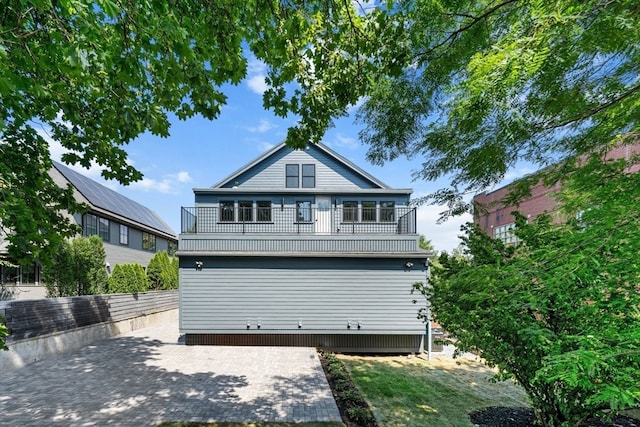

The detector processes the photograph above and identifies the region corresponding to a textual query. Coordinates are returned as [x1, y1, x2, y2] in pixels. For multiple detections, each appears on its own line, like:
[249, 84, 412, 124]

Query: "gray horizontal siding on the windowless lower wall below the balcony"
[180, 257, 426, 335]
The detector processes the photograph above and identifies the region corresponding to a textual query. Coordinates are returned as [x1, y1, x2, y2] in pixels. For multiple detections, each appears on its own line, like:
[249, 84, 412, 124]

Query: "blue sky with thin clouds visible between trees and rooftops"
[49, 55, 526, 251]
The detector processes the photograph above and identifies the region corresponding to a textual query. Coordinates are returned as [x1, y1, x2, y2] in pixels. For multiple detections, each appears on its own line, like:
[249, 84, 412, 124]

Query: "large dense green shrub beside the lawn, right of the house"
[421, 156, 640, 426]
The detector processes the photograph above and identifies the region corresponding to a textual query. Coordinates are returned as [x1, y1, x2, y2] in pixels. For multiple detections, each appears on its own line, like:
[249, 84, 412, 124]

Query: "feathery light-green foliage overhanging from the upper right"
[358, 0, 640, 214]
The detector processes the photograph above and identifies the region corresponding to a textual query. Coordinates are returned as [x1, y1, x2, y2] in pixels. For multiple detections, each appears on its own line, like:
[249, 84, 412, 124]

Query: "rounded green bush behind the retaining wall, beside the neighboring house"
[42, 236, 107, 297]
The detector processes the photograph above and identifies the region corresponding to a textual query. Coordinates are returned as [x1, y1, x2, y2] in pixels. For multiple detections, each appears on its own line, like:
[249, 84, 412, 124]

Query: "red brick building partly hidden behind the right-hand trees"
[473, 143, 640, 244]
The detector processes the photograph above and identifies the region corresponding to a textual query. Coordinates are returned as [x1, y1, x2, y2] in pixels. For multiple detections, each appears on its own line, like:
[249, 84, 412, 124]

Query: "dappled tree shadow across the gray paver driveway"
[0, 336, 340, 426]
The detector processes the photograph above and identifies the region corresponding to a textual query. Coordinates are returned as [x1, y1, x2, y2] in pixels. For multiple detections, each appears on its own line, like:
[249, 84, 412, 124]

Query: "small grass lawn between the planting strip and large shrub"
[339, 355, 529, 427]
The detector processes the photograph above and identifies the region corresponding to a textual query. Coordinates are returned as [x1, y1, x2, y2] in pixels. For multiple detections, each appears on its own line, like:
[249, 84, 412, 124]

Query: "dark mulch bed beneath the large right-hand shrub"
[469, 406, 640, 427]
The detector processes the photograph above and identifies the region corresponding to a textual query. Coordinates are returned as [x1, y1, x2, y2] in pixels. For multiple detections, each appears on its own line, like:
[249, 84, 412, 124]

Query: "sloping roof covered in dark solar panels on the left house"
[53, 161, 176, 238]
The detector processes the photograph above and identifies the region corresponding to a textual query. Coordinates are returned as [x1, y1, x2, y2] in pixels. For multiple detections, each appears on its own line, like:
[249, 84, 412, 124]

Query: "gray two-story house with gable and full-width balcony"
[178, 144, 431, 352]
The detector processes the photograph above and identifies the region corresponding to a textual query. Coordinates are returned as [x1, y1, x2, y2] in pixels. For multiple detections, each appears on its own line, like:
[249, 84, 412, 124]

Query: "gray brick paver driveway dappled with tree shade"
[0, 312, 340, 426]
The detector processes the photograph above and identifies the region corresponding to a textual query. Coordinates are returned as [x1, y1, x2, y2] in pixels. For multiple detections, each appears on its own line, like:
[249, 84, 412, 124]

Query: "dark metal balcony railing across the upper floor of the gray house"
[181, 207, 417, 234]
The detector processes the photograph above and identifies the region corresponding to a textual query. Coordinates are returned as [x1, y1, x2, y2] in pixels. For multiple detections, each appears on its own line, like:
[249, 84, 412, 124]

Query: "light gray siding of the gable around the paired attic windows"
[223, 146, 379, 189]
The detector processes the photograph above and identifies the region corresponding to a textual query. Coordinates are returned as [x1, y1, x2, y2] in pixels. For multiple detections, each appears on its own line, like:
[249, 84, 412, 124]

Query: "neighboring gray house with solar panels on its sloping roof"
[0, 162, 178, 299]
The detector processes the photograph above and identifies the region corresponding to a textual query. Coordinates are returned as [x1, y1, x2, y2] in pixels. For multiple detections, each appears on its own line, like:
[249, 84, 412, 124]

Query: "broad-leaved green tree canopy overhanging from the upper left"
[0, 0, 402, 262]
